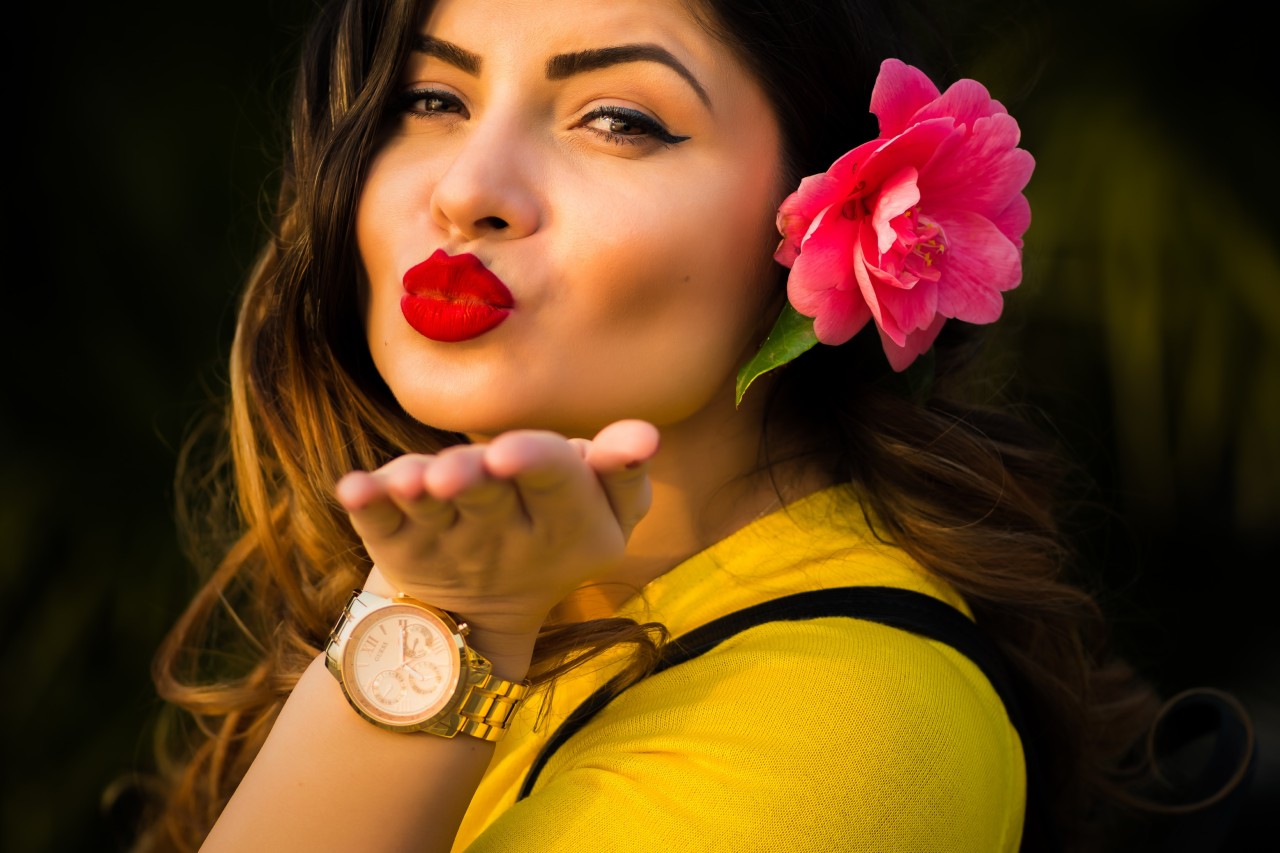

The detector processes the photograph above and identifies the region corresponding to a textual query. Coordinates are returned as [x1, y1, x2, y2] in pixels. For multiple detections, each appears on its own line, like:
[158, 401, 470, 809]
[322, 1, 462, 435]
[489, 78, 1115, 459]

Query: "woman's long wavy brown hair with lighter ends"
[137, 0, 1155, 850]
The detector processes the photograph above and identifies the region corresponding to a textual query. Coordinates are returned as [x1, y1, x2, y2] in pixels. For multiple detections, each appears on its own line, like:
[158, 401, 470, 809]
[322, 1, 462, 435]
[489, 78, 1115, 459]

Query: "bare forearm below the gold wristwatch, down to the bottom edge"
[201, 645, 524, 853]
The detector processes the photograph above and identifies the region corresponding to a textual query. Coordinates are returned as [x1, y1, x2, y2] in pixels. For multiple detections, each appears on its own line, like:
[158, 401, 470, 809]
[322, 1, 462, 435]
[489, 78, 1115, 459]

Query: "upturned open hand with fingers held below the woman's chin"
[337, 420, 658, 655]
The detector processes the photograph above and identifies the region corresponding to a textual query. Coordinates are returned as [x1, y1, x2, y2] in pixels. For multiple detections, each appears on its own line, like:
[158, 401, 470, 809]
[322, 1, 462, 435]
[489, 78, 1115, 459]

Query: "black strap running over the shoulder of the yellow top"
[517, 587, 1060, 852]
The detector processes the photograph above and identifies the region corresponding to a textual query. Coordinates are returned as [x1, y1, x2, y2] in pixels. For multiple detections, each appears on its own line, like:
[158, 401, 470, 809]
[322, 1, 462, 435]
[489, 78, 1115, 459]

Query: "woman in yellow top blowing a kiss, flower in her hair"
[148, 0, 1172, 850]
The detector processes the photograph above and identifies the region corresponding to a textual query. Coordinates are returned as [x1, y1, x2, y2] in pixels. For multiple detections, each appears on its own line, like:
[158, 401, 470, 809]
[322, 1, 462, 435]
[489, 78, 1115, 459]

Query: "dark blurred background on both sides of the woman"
[0, 0, 1280, 853]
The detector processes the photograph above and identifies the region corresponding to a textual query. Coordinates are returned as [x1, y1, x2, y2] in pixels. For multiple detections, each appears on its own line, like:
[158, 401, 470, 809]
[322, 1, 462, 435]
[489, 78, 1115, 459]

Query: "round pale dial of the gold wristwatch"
[342, 596, 461, 725]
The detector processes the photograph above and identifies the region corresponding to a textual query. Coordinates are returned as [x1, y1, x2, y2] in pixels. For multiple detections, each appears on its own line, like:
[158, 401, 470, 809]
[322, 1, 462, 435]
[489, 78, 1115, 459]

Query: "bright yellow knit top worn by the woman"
[453, 487, 1025, 853]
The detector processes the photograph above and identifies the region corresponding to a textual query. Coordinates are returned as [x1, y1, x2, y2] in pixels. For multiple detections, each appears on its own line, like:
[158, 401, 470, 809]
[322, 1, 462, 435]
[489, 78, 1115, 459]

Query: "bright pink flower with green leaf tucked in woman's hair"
[739, 59, 1036, 400]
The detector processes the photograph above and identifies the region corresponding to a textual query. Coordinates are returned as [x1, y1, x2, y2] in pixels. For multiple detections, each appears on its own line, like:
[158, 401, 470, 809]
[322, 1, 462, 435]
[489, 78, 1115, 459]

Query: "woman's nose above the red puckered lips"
[431, 109, 543, 241]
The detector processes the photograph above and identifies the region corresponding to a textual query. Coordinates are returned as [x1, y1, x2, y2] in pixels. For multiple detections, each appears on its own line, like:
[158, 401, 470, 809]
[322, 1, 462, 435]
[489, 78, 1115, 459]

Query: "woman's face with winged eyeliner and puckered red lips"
[357, 0, 783, 435]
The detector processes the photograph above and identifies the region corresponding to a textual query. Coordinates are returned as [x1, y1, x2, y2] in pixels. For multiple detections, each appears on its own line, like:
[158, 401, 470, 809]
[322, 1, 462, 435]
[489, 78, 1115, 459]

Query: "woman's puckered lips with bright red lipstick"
[401, 248, 516, 343]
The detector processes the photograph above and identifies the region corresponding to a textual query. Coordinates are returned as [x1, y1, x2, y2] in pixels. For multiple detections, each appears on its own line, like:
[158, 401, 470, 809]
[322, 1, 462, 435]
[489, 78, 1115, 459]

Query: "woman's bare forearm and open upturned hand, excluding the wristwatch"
[204, 421, 657, 853]
